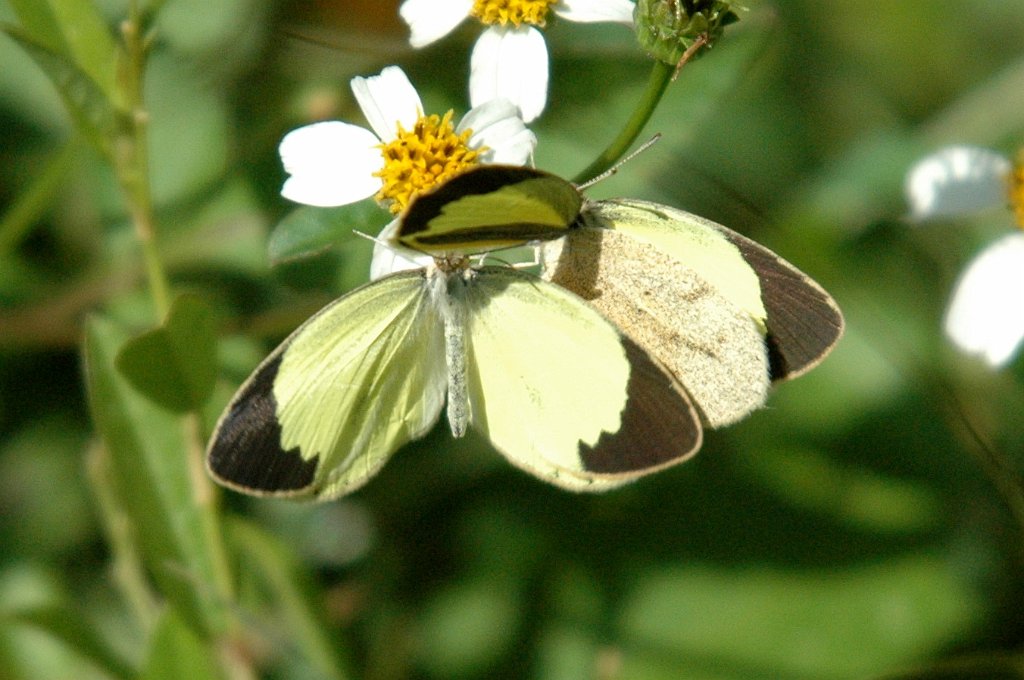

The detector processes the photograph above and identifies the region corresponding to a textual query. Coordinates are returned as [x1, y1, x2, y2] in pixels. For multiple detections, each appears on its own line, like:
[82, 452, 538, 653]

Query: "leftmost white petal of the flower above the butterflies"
[278, 121, 384, 207]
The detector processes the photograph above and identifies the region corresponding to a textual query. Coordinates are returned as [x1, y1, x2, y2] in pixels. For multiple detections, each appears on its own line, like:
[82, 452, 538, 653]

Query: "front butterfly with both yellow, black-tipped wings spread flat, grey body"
[207, 228, 701, 500]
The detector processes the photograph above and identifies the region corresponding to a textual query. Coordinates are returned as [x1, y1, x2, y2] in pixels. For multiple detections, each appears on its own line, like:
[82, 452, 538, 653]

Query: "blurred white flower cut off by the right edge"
[906, 145, 1024, 369]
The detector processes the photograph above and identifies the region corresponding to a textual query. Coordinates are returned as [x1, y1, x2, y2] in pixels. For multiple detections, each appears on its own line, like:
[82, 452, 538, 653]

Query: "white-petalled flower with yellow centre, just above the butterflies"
[279, 67, 537, 213]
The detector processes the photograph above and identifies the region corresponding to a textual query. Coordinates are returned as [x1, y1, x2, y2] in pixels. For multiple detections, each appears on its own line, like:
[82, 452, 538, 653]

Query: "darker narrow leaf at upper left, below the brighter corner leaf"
[3, 25, 117, 157]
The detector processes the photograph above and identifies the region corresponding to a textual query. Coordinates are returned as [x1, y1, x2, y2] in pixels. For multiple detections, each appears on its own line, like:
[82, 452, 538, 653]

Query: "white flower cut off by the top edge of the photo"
[398, 0, 633, 123]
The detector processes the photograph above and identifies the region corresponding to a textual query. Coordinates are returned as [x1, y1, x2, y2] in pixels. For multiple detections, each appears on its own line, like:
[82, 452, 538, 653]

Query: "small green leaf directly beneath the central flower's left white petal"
[267, 199, 390, 264]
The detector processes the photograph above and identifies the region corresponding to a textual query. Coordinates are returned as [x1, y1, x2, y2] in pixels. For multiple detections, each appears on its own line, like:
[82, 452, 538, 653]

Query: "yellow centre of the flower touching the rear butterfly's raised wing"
[374, 111, 487, 215]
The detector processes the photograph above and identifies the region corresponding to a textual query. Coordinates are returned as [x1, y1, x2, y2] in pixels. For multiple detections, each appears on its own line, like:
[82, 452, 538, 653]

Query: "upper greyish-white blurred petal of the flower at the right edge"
[906, 145, 1010, 219]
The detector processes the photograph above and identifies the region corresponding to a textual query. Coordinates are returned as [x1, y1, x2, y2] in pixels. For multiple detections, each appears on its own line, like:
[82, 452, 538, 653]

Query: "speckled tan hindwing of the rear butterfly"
[545, 226, 769, 427]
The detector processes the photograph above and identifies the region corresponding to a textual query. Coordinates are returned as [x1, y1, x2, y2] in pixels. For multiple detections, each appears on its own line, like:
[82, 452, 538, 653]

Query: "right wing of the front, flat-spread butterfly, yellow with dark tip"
[458, 267, 701, 491]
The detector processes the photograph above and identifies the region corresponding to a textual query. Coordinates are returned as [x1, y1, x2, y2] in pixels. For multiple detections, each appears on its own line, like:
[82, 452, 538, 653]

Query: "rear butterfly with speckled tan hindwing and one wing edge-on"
[394, 166, 844, 427]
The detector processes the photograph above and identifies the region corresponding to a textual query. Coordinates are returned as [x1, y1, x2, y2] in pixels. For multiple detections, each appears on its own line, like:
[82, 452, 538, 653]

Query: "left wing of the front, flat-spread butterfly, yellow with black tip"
[207, 270, 446, 499]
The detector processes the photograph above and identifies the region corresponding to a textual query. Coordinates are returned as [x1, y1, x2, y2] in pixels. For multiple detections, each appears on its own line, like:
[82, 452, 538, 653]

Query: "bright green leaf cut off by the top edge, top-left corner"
[10, 0, 118, 101]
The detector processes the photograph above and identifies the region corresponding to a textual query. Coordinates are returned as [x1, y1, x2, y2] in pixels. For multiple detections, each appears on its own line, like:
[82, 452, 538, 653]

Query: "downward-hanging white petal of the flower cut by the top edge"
[469, 26, 548, 123]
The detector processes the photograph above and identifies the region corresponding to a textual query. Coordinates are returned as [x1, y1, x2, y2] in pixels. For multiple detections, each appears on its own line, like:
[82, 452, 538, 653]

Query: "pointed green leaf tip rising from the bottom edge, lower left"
[140, 609, 224, 680]
